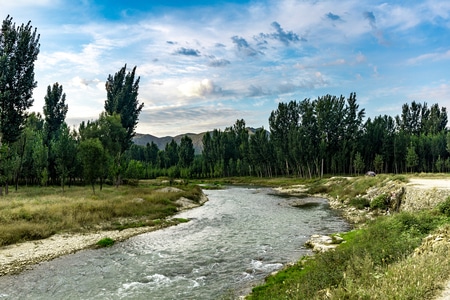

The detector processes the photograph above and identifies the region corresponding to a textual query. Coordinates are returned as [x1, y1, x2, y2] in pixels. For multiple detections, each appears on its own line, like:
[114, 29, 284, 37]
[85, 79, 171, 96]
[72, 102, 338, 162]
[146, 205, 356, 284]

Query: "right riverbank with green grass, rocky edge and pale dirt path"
[248, 175, 450, 300]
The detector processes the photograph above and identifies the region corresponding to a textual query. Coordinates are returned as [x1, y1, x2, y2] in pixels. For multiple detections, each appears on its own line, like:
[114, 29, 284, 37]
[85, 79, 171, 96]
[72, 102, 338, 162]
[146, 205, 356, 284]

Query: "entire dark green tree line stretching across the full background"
[0, 16, 450, 194]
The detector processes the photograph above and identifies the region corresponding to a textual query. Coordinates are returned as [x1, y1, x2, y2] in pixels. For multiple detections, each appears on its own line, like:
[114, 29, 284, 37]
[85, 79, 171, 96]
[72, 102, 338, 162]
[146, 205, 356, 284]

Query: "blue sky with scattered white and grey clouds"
[0, 0, 450, 137]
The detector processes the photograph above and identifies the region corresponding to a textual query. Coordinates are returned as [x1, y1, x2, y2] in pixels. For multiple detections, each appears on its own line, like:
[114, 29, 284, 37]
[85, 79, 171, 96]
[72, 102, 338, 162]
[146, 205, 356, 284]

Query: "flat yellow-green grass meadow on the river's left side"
[0, 183, 201, 246]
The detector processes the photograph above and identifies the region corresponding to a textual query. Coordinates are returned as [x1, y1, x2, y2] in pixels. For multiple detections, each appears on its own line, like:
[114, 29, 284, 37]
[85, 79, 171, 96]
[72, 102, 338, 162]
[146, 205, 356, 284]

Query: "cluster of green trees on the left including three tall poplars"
[0, 16, 147, 194]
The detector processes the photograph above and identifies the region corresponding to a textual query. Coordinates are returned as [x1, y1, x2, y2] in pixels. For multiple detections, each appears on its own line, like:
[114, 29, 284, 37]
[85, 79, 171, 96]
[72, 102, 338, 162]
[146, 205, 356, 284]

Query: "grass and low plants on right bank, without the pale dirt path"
[246, 176, 450, 299]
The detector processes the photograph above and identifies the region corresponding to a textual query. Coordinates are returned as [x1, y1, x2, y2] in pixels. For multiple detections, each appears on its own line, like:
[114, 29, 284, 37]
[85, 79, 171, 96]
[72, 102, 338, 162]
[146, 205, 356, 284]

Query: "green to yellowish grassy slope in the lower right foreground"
[247, 212, 450, 299]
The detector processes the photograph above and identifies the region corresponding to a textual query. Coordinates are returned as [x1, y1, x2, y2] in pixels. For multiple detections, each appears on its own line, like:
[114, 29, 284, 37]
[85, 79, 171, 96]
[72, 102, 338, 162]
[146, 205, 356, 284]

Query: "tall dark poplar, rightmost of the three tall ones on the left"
[105, 65, 144, 153]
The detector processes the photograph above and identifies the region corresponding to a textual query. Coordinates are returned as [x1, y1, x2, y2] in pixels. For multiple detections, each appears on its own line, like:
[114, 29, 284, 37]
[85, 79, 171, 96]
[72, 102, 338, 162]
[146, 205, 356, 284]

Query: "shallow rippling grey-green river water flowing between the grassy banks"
[0, 187, 349, 299]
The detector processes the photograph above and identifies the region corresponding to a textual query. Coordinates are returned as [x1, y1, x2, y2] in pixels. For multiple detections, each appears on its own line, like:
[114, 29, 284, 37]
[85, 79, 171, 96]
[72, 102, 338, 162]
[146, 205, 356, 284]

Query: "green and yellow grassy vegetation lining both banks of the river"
[0, 175, 450, 299]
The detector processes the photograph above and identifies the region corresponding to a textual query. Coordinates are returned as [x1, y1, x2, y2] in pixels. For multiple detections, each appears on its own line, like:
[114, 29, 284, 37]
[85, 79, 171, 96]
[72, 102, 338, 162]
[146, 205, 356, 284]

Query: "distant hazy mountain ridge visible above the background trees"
[133, 127, 262, 154]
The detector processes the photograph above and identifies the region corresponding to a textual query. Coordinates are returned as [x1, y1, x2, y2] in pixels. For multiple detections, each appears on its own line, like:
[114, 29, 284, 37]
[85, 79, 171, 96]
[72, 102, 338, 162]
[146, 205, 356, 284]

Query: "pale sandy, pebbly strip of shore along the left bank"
[0, 187, 208, 276]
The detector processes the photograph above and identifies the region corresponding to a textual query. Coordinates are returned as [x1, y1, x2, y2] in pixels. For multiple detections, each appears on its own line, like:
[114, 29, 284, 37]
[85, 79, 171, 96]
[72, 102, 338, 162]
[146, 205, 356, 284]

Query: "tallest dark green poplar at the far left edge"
[0, 16, 40, 143]
